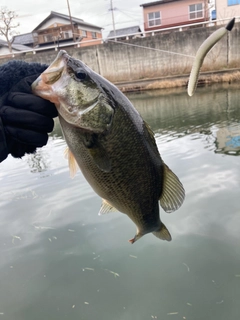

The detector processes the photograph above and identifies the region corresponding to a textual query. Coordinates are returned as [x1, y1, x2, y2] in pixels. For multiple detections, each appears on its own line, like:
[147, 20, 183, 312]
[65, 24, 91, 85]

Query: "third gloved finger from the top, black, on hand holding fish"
[4, 126, 48, 147]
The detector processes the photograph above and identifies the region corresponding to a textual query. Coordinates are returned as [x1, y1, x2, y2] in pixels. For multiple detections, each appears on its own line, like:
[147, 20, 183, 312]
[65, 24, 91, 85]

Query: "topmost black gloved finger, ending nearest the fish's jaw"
[7, 92, 58, 118]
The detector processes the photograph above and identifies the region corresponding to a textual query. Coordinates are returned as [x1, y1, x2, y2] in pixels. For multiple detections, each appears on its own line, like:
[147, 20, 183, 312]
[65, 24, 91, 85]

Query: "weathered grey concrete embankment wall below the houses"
[0, 23, 240, 82]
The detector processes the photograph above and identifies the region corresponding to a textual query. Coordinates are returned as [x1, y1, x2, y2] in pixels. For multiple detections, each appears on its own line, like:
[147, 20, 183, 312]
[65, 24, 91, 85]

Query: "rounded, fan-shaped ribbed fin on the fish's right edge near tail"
[159, 163, 185, 213]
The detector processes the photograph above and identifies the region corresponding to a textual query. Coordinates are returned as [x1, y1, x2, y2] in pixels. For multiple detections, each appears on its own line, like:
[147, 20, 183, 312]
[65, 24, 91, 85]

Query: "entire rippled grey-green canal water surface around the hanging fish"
[0, 85, 240, 320]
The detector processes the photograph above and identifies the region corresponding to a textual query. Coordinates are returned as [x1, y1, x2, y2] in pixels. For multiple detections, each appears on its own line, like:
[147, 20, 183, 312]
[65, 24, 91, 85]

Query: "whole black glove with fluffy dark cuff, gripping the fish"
[0, 61, 58, 161]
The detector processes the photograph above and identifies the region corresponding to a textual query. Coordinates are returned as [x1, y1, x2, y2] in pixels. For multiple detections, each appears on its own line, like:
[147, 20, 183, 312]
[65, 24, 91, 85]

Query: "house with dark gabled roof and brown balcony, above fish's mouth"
[32, 11, 102, 47]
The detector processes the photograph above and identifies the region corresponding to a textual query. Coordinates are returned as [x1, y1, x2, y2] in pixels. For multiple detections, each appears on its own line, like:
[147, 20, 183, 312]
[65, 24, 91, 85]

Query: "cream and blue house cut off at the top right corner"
[215, 0, 240, 23]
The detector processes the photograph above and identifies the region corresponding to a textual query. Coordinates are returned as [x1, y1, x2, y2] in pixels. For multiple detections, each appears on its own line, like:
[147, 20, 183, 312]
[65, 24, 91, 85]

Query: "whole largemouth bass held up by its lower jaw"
[32, 51, 185, 243]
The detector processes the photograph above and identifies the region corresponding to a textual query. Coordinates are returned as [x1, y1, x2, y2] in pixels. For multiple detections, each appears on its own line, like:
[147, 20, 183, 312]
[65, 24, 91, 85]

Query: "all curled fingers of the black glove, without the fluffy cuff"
[0, 92, 57, 158]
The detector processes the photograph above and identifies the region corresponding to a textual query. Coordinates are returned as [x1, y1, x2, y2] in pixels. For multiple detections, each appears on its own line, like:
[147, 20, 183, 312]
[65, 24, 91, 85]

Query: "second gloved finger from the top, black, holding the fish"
[0, 106, 54, 132]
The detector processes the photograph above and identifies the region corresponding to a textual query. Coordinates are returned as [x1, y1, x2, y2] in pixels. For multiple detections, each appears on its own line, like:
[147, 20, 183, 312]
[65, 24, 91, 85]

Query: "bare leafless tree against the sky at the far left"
[0, 7, 20, 52]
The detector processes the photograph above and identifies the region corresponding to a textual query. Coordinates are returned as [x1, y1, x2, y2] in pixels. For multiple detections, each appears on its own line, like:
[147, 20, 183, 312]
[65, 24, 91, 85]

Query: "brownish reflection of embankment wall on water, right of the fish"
[129, 85, 240, 155]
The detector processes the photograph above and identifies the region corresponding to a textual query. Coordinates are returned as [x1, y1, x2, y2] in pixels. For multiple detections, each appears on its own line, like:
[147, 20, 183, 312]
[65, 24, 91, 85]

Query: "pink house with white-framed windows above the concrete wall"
[140, 0, 209, 31]
